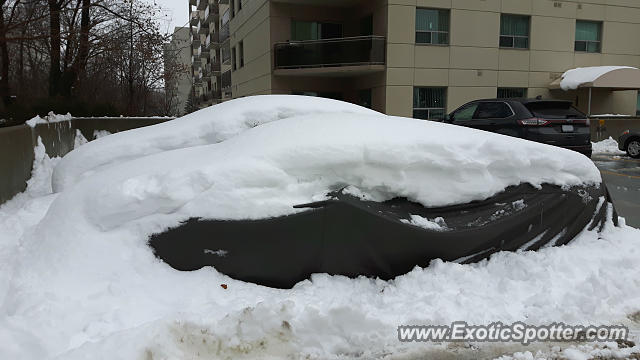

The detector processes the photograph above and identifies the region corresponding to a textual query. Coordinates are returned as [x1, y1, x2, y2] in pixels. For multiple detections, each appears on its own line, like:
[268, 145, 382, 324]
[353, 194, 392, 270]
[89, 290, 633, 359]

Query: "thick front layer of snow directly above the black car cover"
[45, 113, 601, 233]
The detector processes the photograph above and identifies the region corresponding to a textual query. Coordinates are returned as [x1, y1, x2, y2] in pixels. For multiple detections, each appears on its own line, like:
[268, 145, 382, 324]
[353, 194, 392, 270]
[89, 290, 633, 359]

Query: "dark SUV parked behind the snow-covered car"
[446, 99, 592, 157]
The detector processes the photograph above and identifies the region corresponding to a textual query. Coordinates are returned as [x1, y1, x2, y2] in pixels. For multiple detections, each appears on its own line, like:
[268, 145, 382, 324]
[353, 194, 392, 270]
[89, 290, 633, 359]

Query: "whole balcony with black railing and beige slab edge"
[274, 36, 386, 76]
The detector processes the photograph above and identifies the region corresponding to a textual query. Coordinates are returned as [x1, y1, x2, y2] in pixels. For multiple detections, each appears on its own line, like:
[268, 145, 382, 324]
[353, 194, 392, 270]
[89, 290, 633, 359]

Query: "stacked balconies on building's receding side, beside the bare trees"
[189, 0, 231, 108]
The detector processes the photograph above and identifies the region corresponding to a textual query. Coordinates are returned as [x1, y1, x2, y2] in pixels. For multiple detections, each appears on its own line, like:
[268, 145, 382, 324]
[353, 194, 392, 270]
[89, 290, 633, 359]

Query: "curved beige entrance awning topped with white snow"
[549, 66, 640, 91]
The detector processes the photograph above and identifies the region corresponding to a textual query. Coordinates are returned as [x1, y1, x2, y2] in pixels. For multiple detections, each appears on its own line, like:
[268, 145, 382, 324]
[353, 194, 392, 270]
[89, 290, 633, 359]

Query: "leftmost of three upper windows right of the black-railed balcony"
[416, 9, 449, 45]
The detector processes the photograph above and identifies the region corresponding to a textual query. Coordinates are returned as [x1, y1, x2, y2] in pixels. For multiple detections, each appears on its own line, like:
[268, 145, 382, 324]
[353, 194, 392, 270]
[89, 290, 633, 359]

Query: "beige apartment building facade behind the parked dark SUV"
[209, 0, 640, 119]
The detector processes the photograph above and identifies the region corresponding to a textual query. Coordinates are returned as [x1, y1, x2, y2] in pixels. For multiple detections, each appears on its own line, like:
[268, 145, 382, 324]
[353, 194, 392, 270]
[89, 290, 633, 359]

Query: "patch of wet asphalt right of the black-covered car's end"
[593, 154, 640, 228]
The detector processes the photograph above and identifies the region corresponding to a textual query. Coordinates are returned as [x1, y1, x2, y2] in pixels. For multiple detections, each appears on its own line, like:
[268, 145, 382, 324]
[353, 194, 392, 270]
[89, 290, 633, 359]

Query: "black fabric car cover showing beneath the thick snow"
[149, 184, 617, 288]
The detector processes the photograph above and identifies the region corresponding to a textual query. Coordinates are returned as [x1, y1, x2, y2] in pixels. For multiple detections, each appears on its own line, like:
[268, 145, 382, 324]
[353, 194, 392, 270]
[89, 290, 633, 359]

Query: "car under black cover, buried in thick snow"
[50, 96, 617, 287]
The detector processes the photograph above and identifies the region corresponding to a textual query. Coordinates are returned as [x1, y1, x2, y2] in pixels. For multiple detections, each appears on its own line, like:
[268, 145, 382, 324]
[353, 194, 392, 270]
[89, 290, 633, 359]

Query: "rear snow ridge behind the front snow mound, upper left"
[53, 95, 379, 192]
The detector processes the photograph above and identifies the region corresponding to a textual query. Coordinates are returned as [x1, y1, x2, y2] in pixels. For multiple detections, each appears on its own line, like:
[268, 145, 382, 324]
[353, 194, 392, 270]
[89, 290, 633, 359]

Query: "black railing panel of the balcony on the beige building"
[275, 36, 385, 69]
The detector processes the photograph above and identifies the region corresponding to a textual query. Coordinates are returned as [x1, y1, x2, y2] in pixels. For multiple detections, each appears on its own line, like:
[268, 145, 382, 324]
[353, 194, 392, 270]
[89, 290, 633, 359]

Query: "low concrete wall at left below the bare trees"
[0, 118, 170, 204]
